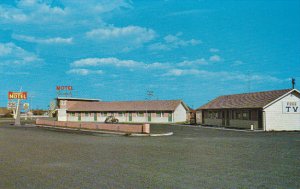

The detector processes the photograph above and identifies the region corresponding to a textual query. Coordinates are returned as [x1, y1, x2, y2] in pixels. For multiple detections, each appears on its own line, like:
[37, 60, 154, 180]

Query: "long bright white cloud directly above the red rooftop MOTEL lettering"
[71, 57, 144, 67]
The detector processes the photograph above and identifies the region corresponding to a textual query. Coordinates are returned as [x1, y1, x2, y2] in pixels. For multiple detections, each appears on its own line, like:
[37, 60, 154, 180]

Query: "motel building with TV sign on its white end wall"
[196, 89, 300, 131]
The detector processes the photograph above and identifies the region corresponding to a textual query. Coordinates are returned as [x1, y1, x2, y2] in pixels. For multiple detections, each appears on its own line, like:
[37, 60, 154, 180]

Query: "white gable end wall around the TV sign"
[264, 92, 300, 131]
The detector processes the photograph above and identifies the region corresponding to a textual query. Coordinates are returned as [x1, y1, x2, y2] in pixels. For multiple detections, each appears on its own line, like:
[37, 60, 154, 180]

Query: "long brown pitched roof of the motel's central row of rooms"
[68, 100, 187, 111]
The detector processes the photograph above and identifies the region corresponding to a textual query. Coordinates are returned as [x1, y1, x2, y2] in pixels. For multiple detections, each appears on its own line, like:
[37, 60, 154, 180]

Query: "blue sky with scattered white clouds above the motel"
[0, 0, 300, 108]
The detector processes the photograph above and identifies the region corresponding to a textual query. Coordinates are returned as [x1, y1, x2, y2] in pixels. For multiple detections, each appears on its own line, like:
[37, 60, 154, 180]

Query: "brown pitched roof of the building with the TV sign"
[197, 89, 291, 110]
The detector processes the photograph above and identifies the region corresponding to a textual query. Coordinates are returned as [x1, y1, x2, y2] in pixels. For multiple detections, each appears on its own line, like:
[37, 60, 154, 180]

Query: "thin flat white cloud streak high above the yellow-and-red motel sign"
[12, 34, 73, 44]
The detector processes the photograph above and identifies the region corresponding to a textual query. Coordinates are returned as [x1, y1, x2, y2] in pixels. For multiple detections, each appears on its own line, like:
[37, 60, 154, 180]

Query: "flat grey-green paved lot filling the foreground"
[0, 123, 300, 189]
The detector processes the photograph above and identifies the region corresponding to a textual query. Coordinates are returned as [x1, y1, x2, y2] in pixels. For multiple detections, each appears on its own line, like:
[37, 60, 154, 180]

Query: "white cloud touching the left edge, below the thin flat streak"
[0, 43, 43, 66]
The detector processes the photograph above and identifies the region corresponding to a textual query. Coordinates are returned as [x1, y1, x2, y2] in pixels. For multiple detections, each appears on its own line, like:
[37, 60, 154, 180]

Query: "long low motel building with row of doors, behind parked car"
[56, 97, 188, 123]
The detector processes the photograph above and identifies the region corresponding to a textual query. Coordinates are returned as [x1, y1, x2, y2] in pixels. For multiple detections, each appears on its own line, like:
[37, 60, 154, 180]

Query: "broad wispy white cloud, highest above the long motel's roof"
[86, 26, 156, 44]
